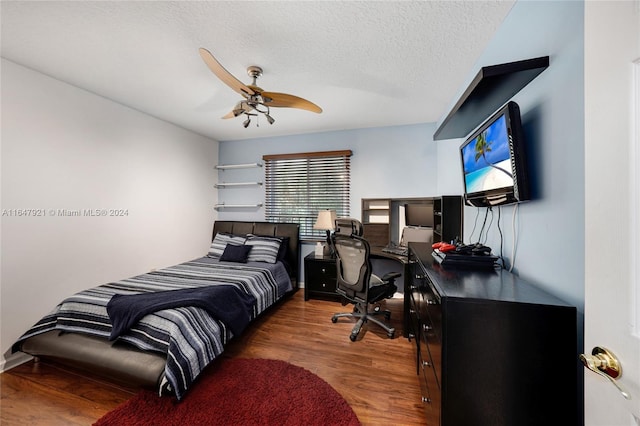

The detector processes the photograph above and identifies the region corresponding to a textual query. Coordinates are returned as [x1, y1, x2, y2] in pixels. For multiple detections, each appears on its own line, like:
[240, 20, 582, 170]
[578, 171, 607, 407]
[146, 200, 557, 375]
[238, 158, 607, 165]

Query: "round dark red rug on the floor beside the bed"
[94, 359, 360, 426]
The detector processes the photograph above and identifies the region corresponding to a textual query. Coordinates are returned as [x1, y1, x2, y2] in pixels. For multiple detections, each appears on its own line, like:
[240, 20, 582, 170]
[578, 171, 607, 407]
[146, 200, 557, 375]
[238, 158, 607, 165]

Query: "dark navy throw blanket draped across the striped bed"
[107, 285, 256, 340]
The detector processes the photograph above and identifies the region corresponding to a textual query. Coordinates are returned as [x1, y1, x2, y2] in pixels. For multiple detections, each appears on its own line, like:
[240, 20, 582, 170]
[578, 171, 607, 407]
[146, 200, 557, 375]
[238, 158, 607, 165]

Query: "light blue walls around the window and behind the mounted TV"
[218, 1, 584, 312]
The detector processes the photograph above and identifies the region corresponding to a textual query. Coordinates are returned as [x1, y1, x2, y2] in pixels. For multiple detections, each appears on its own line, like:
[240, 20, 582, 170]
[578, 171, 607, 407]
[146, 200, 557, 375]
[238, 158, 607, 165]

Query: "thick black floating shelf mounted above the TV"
[433, 56, 549, 140]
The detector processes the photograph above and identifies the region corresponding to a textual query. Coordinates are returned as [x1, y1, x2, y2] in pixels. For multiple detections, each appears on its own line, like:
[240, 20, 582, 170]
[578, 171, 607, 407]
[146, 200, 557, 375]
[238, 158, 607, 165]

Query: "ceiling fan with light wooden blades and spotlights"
[199, 47, 322, 128]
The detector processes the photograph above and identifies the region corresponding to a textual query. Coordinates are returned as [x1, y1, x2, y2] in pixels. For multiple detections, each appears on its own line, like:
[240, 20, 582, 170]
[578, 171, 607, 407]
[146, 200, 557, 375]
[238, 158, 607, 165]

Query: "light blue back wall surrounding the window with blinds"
[218, 122, 442, 220]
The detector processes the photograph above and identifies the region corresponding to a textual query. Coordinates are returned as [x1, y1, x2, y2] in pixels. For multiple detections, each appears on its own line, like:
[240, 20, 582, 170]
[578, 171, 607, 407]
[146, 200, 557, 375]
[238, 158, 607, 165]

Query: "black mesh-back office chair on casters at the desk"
[331, 219, 401, 342]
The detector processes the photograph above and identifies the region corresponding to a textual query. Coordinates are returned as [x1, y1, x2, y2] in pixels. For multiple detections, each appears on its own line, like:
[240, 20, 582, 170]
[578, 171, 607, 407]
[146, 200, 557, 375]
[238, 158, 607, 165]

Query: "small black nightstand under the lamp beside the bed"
[304, 253, 340, 300]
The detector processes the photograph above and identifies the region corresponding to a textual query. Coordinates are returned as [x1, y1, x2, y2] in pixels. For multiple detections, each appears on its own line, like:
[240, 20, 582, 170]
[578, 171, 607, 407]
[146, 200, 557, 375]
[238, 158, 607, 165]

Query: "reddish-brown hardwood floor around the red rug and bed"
[0, 290, 426, 426]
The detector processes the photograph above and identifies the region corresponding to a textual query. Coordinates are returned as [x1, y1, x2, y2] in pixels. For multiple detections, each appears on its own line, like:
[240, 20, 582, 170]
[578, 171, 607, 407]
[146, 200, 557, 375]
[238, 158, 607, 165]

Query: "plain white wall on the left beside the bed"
[0, 59, 218, 365]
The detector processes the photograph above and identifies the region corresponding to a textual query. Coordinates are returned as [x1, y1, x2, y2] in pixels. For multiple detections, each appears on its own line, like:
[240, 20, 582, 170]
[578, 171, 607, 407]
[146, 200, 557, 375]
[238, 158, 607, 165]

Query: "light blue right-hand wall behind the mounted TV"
[450, 1, 585, 312]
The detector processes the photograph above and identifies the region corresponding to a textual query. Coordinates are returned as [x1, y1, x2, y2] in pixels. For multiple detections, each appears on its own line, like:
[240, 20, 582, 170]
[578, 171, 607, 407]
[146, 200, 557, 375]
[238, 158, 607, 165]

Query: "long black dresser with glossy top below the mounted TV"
[409, 243, 582, 426]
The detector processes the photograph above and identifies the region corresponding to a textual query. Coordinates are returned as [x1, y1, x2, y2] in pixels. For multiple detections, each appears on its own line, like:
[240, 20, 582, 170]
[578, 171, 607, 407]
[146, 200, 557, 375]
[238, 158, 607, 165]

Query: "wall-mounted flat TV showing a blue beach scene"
[460, 102, 529, 207]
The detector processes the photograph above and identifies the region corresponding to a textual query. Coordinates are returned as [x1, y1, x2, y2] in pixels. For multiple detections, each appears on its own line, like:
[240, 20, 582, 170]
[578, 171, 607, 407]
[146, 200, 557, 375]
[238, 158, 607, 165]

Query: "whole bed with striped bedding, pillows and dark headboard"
[12, 221, 300, 399]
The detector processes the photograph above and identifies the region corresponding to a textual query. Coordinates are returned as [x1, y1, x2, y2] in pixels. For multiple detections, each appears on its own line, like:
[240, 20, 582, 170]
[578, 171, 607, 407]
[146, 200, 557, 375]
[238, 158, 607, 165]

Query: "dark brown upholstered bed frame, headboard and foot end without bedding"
[20, 221, 300, 389]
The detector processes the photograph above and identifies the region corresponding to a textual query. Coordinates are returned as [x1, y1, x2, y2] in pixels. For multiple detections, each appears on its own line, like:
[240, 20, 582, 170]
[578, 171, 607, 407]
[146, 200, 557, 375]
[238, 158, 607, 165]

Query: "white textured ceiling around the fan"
[0, 0, 517, 141]
